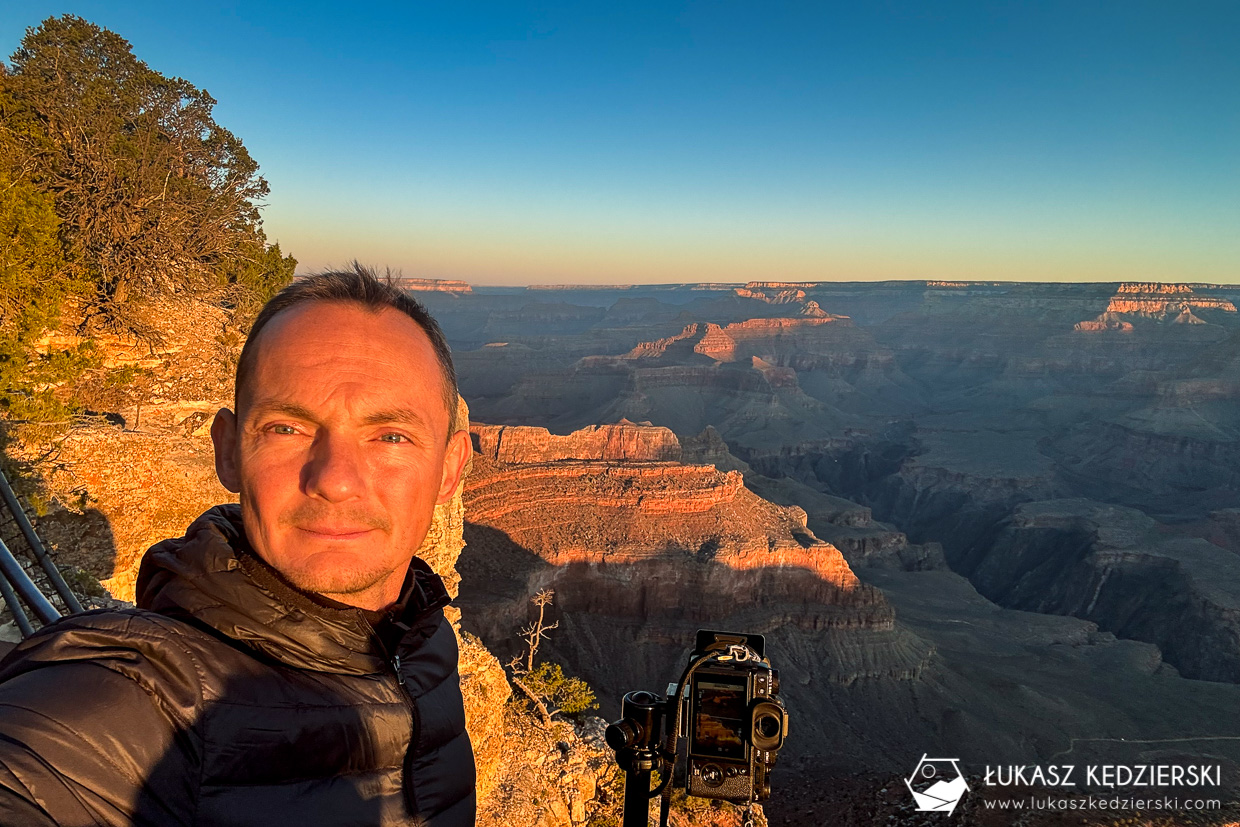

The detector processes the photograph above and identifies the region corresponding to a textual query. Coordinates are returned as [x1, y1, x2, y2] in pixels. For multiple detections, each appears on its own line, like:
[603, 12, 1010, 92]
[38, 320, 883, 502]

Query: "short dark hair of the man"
[233, 262, 461, 436]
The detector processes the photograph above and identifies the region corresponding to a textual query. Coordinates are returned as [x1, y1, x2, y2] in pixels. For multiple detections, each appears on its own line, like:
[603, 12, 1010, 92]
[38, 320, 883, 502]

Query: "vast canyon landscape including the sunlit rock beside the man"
[7, 279, 1240, 827]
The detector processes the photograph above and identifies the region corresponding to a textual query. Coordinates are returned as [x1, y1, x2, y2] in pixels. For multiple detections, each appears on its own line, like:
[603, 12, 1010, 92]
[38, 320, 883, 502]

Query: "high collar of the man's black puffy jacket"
[136, 503, 449, 674]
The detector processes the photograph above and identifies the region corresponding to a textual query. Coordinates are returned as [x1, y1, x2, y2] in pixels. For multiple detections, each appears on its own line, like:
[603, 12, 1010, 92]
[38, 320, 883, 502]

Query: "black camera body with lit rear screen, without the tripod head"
[683, 631, 787, 801]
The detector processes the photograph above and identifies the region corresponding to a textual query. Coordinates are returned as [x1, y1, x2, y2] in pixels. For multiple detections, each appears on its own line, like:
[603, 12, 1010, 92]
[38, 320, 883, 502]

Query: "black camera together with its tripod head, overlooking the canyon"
[606, 630, 787, 827]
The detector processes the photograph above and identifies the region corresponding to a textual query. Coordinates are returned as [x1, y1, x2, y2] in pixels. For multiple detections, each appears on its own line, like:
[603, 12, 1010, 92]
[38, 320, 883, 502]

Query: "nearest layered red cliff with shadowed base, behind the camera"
[460, 426, 932, 768]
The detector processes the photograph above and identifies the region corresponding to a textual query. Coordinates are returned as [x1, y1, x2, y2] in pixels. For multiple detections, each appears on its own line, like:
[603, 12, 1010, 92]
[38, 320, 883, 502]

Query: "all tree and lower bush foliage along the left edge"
[0, 15, 296, 458]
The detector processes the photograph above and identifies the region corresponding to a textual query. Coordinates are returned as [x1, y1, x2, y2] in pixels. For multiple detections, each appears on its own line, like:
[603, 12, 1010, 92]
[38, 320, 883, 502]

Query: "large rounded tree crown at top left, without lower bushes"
[0, 15, 293, 330]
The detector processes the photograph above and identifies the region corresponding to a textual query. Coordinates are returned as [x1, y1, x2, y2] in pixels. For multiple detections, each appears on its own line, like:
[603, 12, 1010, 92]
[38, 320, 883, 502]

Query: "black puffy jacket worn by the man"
[0, 506, 475, 827]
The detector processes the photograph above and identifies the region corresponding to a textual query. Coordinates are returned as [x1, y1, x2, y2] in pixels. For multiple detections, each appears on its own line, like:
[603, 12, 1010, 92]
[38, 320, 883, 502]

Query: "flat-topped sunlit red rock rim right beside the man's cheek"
[470, 420, 681, 462]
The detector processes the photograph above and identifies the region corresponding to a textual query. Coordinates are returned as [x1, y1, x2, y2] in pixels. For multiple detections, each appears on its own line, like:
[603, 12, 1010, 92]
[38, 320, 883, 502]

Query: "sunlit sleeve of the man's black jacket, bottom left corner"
[0, 662, 198, 827]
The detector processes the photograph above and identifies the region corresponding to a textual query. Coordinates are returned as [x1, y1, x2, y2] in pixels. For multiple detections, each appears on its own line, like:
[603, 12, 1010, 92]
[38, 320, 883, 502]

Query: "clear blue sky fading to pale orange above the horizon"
[0, 0, 1240, 284]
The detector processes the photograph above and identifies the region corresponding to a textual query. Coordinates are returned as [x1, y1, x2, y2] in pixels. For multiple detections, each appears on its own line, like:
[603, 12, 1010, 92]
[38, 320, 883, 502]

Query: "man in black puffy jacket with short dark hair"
[0, 265, 475, 827]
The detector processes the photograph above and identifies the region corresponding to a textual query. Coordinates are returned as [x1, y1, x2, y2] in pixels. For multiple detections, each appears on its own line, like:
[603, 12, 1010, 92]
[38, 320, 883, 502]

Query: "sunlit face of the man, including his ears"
[211, 301, 470, 609]
